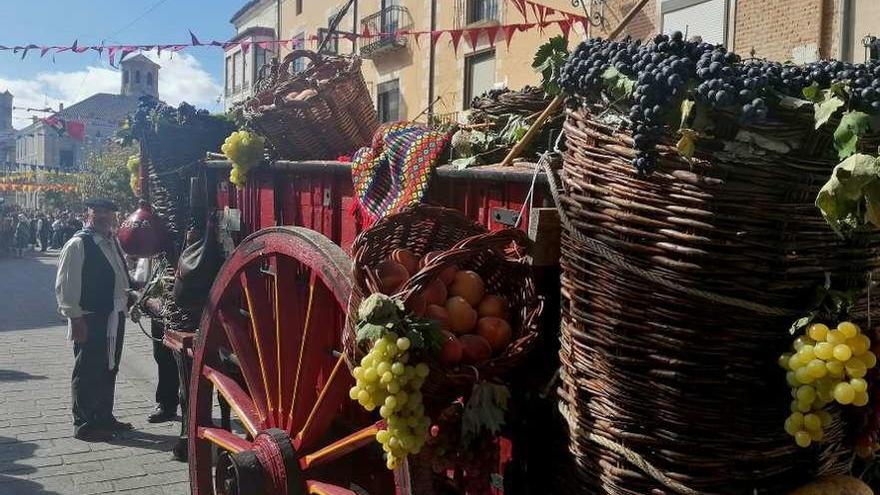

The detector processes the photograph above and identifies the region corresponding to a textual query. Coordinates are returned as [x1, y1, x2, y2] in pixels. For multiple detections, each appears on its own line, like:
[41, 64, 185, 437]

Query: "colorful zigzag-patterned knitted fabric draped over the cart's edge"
[351, 122, 452, 226]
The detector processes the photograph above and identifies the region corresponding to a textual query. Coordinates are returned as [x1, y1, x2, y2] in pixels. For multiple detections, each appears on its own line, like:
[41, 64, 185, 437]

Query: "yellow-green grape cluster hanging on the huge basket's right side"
[779, 321, 877, 447]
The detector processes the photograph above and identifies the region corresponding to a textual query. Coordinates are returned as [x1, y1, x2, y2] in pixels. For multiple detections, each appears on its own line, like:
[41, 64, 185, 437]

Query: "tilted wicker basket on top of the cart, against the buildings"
[243, 50, 379, 160]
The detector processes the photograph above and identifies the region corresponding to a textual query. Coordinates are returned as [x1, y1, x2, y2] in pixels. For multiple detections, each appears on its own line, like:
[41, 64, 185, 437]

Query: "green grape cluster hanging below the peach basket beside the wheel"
[349, 332, 431, 469]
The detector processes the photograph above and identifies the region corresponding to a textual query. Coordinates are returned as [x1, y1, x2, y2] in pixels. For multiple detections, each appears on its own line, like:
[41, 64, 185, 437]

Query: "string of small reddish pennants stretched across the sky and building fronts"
[0, 0, 589, 67]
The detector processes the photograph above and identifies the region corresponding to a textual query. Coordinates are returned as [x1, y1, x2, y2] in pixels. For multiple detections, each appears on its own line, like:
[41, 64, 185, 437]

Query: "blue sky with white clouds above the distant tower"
[0, 0, 246, 128]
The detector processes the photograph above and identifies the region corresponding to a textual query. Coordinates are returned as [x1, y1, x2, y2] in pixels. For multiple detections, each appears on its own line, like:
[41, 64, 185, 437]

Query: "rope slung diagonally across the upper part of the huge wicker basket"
[540, 153, 798, 316]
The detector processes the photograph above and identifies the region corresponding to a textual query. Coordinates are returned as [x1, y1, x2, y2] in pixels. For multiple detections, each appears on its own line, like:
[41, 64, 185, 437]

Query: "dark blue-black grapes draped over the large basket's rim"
[559, 32, 880, 174]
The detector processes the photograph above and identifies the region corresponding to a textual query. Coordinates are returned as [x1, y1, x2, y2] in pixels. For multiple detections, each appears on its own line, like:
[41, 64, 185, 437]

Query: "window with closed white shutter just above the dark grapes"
[660, 0, 727, 45]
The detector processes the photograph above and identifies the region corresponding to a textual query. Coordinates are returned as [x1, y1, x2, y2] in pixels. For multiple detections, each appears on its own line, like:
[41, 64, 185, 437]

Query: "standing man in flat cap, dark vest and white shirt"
[55, 198, 131, 441]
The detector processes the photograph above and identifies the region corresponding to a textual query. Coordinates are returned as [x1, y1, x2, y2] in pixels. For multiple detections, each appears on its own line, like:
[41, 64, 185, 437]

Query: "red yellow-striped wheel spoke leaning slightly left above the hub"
[241, 269, 279, 426]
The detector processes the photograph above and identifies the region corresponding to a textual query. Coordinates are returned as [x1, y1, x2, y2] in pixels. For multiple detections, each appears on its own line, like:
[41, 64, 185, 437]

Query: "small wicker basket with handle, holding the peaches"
[343, 205, 542, 400]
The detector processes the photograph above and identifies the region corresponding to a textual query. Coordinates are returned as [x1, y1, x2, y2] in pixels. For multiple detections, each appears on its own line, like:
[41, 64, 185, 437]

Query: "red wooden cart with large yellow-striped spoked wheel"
[166, 161, 558, 495]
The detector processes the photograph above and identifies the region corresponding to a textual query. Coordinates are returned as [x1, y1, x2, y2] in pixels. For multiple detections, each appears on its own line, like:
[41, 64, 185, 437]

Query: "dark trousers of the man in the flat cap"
[70, 313, 125, 432]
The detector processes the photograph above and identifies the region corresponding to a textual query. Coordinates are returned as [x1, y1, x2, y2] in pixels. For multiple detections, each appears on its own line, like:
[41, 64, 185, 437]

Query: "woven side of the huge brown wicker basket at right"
[558, 106, 880, 495]
